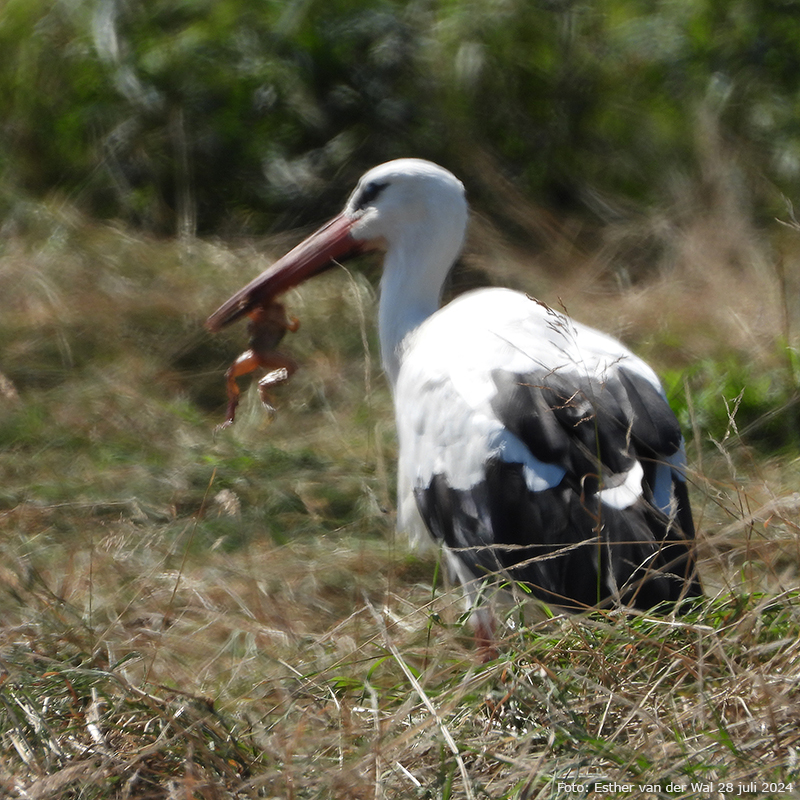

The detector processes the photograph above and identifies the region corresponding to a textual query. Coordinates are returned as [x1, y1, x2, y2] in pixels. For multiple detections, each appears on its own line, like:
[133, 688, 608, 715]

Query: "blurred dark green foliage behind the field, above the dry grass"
[0, 0, 800, 233]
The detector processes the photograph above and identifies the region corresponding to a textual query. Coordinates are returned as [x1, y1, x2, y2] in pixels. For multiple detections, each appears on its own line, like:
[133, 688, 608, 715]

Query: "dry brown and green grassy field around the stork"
[0, 195, 800, 800]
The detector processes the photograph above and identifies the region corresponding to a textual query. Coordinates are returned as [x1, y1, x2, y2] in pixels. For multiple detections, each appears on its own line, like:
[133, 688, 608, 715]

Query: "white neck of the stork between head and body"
[378, 250, 450, 389]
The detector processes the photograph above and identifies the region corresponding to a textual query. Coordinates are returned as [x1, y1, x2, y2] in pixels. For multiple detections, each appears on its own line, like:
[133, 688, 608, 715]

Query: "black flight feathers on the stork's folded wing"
[415, 367, 701, 608]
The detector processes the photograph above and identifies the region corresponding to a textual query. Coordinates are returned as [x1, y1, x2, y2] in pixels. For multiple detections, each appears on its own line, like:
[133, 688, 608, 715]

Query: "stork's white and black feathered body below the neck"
[395, 289, 695, 607]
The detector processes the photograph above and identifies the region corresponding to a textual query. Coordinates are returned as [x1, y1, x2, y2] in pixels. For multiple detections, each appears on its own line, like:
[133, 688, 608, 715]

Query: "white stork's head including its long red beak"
[206, 158, 468, 331]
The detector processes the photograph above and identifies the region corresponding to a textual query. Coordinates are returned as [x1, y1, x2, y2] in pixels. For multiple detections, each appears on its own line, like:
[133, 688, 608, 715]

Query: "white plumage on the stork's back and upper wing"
[395, 289, 680, 513]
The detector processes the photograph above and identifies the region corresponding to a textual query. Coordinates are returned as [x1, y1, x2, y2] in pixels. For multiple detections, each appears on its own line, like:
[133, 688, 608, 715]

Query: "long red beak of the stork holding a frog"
[206, 214, 368, 333]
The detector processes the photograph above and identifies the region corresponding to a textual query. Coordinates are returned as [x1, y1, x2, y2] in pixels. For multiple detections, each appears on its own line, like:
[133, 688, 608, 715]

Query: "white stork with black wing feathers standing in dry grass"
[207, 159, 701, 638]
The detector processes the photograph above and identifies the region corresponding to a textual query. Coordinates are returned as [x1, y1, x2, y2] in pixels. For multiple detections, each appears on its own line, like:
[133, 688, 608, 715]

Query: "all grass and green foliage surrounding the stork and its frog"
[0, 0, 800, 800]
